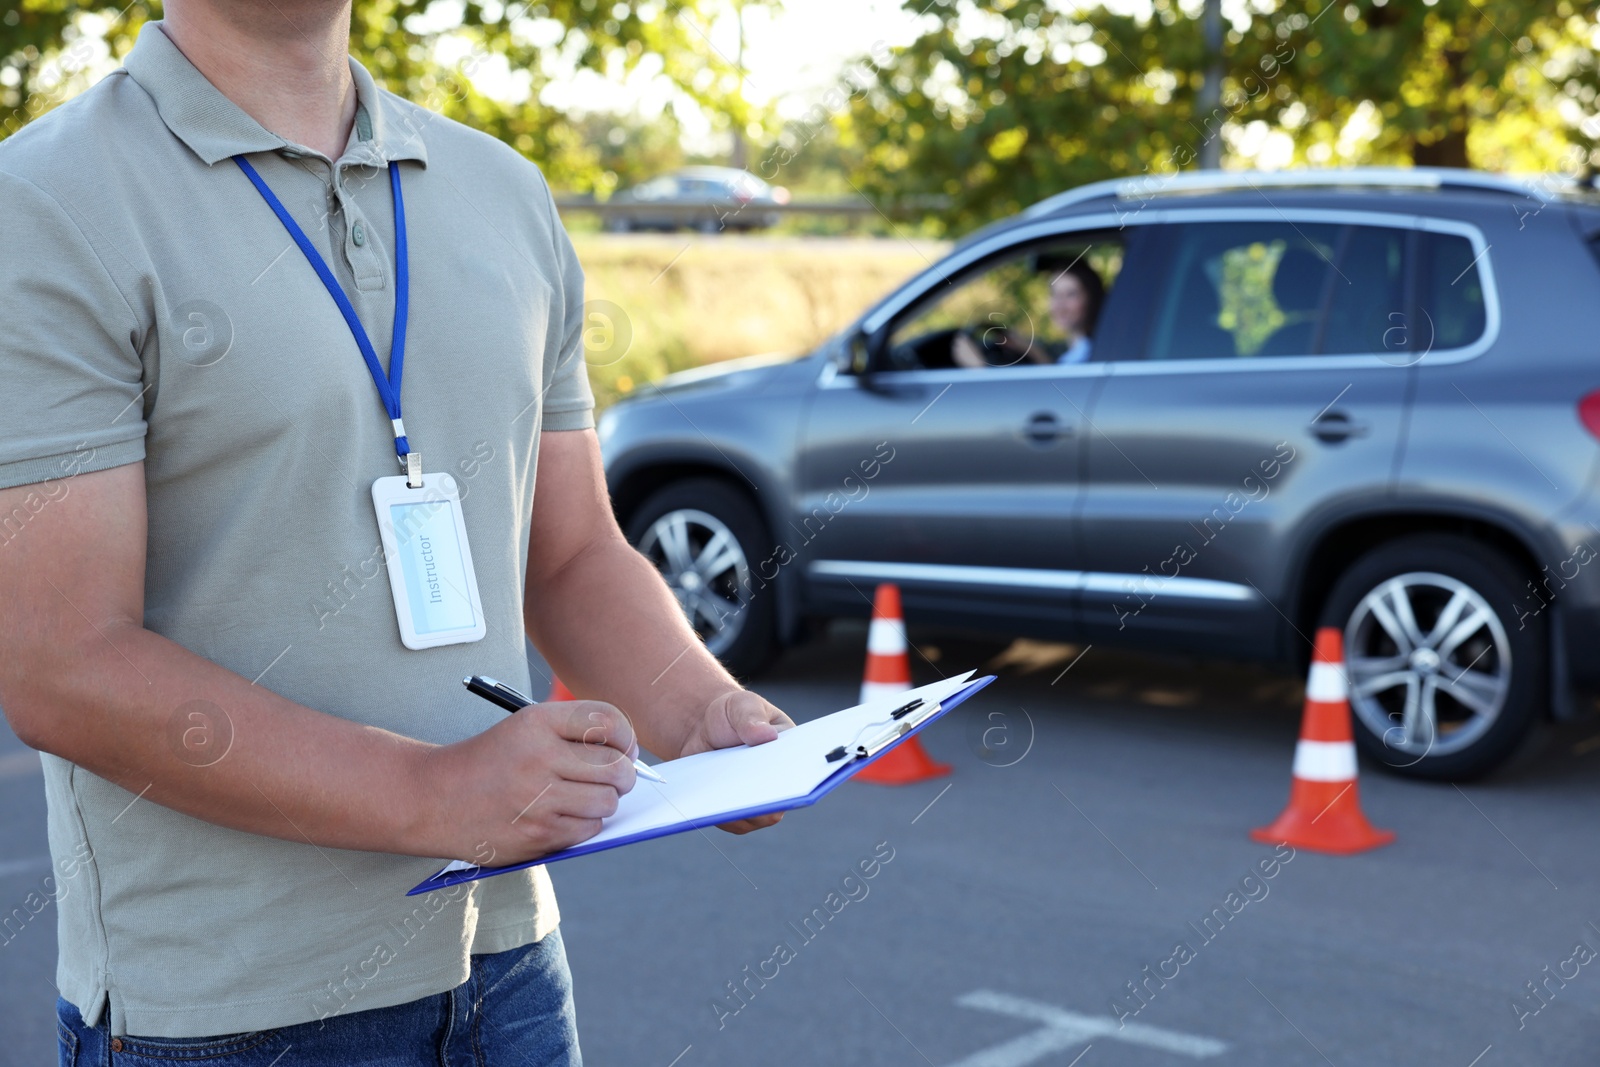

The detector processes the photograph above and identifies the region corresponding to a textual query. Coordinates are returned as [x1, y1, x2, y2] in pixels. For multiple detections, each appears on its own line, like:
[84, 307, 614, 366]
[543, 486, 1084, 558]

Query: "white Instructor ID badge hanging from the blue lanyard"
[373, 472, 488, 648]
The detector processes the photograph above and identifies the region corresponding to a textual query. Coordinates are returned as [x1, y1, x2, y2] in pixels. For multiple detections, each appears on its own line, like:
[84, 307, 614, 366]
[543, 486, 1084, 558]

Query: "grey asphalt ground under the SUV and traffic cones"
[0, 629, 1600, 1067]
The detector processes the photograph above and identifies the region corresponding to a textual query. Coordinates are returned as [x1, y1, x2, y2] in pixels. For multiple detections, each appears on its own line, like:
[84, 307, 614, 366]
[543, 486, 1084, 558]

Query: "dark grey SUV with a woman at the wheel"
[602, 170, 1600, 779]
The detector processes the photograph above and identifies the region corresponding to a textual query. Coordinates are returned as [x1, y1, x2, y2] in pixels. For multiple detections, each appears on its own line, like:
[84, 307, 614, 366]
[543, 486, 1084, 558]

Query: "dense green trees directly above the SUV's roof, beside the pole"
[843, 0, 1600, 230]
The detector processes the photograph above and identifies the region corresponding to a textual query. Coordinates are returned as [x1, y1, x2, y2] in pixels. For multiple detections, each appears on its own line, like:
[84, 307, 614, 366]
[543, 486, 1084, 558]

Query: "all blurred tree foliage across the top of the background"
[12, 0, 1600, 230]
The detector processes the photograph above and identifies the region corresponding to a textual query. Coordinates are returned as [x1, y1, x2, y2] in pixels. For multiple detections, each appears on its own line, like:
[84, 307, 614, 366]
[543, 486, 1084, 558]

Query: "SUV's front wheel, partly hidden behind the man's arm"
[627, 478, 778, 677]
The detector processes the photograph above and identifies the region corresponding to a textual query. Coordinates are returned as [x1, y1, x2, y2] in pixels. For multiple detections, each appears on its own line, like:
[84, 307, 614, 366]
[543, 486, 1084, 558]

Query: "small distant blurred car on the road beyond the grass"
[606, 166, 789, 234]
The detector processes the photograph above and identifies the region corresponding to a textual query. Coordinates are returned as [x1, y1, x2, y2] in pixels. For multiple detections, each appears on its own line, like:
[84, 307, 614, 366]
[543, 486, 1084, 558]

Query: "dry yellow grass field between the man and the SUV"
[573, 234, 947, 408]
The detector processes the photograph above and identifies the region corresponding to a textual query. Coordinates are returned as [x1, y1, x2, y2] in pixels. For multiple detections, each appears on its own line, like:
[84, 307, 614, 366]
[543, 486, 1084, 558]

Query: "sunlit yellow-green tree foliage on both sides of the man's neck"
[0, 0, 774, 192]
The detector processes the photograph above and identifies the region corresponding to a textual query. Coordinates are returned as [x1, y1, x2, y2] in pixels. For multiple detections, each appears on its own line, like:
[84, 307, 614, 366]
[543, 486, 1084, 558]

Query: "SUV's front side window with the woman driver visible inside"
[883, 235, 1123, 370]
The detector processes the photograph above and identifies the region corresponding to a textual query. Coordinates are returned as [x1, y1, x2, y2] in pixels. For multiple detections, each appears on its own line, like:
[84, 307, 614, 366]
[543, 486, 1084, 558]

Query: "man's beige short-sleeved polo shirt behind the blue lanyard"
[0, 24, 592, 1037]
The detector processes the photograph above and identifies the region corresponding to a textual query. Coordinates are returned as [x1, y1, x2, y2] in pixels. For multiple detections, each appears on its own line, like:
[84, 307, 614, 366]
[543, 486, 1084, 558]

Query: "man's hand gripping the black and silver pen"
[419, 701, 638, 867]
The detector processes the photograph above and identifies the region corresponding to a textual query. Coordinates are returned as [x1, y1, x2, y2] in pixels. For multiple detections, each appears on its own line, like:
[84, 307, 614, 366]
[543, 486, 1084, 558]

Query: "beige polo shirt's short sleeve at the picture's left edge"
[0, 173, 146, 488]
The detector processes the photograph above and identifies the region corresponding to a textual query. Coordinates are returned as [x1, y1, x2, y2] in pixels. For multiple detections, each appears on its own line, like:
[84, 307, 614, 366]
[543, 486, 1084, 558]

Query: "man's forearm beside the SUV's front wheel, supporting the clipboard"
[523, 536, 739, 760]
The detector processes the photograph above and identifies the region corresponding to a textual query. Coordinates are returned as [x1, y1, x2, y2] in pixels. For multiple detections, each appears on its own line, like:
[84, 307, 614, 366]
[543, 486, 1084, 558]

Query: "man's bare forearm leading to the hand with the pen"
[0, 624, 440, 854]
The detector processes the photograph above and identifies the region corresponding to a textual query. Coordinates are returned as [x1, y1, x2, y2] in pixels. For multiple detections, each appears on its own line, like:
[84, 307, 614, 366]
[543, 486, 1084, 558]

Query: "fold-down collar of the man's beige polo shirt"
[123, 22, 427, 166]
